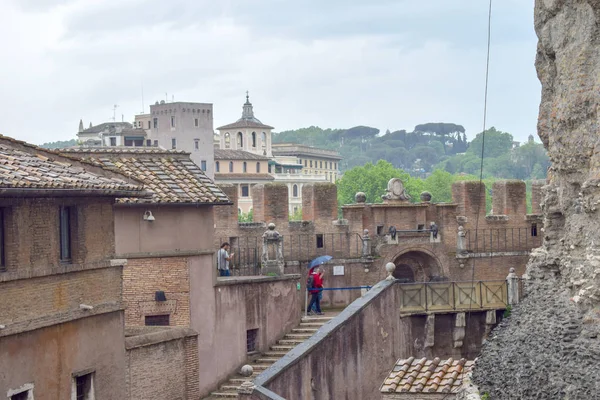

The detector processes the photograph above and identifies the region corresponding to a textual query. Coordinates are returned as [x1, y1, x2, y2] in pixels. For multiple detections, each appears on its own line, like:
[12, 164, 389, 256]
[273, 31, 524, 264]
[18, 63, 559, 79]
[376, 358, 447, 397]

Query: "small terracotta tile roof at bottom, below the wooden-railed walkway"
[380, 357, 473, 393]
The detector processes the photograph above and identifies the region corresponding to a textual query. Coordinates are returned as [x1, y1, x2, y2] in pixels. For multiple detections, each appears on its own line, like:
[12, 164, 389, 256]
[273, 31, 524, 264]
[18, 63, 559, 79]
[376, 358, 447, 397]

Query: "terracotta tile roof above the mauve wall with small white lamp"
[62, 147, 229, 204]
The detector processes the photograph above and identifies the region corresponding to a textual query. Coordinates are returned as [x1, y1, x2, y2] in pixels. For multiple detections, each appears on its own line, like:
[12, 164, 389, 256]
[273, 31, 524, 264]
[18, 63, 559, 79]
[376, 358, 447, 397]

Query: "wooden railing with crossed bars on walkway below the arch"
[399, 280, 508, 314]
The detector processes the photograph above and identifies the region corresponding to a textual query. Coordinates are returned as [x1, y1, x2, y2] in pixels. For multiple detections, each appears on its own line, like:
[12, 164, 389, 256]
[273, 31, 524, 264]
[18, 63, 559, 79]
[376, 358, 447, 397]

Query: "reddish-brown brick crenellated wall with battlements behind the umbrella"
[215, 180, 544, 285]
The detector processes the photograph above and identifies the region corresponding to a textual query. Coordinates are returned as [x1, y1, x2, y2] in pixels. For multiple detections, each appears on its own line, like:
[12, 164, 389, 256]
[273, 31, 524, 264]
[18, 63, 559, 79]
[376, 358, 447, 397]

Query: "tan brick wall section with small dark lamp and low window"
[123, 257, 190, 326]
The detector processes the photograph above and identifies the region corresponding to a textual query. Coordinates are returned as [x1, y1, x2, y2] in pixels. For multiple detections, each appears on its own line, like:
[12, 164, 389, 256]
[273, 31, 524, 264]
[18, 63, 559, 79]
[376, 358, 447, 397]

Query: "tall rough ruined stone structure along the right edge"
[473, 0, 600, 399]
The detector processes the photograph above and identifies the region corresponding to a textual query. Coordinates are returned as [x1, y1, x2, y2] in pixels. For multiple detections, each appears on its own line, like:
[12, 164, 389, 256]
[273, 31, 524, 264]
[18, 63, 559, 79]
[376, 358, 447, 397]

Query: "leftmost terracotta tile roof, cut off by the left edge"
[0, 135, 147, 197]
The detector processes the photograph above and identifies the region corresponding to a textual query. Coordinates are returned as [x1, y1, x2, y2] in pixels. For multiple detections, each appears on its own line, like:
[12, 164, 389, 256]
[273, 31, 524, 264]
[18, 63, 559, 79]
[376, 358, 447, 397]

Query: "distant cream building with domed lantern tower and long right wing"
[214, 94, 341, 213]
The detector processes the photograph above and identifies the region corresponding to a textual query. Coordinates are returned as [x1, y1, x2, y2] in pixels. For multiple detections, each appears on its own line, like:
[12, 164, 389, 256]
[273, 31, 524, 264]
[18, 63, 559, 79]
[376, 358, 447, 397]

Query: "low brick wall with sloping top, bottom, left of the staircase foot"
[125, 327, 199, 400]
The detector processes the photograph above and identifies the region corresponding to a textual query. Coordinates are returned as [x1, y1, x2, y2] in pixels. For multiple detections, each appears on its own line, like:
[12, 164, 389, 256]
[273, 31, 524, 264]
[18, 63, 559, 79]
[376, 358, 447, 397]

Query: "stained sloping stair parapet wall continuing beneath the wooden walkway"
[243, 280, 500, 400]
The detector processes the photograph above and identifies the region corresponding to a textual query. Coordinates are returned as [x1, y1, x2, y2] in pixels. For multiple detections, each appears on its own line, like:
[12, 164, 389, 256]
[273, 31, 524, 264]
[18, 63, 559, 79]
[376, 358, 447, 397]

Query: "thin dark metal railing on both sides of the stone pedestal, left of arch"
[219, 232, 363, 276]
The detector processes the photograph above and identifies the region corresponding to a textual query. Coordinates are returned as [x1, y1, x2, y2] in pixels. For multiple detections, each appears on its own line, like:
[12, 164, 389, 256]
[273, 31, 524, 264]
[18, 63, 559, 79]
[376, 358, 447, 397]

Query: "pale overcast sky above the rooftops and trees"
[0, 0, 540, 143]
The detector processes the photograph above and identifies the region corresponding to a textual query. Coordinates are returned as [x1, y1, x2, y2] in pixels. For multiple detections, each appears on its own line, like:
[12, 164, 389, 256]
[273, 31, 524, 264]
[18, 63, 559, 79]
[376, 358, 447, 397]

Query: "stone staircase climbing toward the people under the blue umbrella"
[204, 311, 338, 400]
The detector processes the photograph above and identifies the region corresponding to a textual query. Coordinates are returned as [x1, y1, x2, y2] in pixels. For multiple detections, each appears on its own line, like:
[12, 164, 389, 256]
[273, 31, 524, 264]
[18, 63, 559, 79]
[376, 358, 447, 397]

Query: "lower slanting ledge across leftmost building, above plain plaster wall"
[0, 301, 124, 338]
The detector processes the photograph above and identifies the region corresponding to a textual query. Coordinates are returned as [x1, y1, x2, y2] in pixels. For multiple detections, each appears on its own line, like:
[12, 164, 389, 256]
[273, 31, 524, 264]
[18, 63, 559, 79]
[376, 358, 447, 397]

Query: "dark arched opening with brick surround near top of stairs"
[393, 249, 444, 282]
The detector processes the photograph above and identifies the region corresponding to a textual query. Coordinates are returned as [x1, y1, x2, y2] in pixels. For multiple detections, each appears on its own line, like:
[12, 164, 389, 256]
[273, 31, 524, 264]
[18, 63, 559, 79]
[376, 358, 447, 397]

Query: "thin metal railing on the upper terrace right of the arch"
[465, 228, 543, 253]
